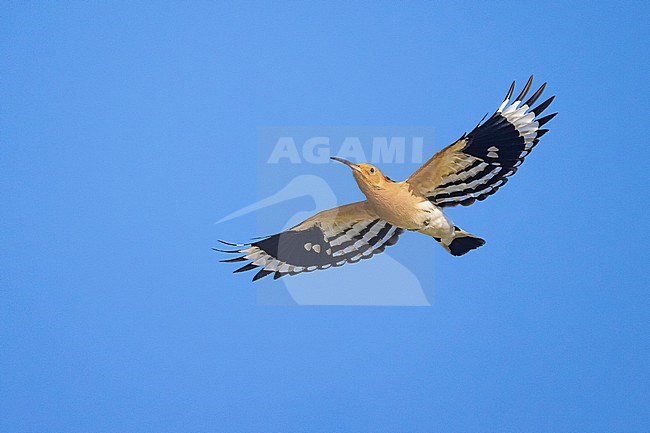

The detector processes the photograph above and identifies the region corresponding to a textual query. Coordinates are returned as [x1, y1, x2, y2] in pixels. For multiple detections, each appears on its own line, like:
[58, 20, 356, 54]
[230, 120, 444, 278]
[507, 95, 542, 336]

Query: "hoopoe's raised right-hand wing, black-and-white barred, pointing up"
[407, 76, 557, 207]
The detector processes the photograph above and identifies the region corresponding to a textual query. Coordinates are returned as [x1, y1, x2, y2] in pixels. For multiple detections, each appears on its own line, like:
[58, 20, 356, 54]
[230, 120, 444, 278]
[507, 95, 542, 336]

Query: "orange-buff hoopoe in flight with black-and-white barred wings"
[217, 76, 557, 281]
